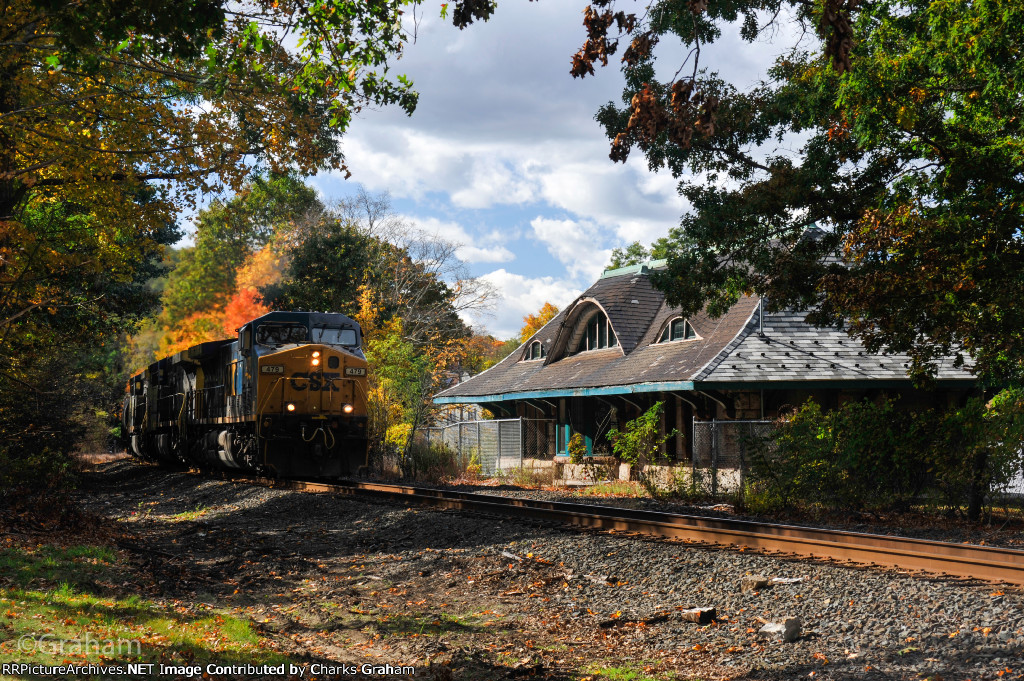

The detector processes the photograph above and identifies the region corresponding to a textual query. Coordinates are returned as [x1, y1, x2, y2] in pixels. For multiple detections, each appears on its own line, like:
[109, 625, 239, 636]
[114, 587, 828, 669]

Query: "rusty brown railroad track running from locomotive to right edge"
[214, 476, 1024, 585]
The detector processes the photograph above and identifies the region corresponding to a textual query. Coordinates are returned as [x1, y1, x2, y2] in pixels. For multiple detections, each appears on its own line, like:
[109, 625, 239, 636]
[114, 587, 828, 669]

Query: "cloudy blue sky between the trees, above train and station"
[311, 0, 778, 338]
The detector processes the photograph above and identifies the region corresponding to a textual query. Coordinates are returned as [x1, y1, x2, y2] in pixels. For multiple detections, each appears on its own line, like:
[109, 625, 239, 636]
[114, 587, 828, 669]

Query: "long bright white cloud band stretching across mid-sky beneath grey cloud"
[335, 126, 687, 246]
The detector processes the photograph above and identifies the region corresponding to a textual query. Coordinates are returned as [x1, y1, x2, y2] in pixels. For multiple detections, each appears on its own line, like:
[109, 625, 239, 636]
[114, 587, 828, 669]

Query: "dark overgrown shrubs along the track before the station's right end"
[745, 391, 1024, 519]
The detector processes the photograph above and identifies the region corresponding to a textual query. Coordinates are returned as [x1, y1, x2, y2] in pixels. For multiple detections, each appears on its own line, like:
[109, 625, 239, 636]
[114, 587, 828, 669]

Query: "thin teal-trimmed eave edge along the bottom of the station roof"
[433, 379, 978, 405]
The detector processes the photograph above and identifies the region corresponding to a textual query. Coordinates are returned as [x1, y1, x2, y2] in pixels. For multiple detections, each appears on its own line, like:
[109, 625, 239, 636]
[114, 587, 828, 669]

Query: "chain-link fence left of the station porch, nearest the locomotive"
[416, 419, 554, 475]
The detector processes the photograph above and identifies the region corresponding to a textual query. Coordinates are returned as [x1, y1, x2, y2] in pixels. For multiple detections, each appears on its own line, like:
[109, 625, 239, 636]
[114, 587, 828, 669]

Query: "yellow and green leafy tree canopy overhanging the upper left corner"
[0, 0, 490, 366]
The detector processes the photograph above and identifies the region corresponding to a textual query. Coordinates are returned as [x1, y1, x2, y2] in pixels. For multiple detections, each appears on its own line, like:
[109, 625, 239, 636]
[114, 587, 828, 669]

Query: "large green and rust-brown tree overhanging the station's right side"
[572, 0, 1024, 380]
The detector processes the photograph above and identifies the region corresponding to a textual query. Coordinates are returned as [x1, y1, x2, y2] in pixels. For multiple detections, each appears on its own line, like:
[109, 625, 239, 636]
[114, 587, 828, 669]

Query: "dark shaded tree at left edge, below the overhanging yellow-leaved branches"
[0, 196, 177, 503]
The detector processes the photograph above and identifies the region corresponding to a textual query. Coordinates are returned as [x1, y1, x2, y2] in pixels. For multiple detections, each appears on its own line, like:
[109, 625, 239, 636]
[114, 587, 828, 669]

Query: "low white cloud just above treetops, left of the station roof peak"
[467, 267, 589, 338]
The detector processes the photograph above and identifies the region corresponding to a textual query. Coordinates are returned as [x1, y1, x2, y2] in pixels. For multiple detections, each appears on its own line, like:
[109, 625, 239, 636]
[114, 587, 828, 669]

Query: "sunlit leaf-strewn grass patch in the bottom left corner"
[0, 546, 289, 665]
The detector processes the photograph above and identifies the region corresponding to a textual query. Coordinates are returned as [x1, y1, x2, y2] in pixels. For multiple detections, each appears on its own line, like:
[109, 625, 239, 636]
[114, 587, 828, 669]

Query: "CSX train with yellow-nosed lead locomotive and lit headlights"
[122, 312, 367, 477]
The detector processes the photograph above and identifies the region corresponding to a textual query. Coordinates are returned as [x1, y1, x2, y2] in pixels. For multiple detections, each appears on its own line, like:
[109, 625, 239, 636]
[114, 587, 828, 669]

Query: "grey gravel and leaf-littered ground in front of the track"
[74, 462, 1024, 681]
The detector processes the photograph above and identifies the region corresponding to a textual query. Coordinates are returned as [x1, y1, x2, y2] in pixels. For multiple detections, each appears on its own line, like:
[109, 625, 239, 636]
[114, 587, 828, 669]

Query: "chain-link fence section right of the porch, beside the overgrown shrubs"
[690, 420, 775, 499]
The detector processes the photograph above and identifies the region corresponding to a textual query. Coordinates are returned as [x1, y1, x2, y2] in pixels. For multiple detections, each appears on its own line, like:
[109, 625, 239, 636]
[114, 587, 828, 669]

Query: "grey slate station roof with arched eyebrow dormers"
[434, 263, 974, 402]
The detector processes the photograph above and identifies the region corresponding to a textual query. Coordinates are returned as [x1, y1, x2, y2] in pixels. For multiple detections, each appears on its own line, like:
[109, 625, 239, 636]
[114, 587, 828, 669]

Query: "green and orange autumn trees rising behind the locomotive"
[138, 183, 495, 472]
